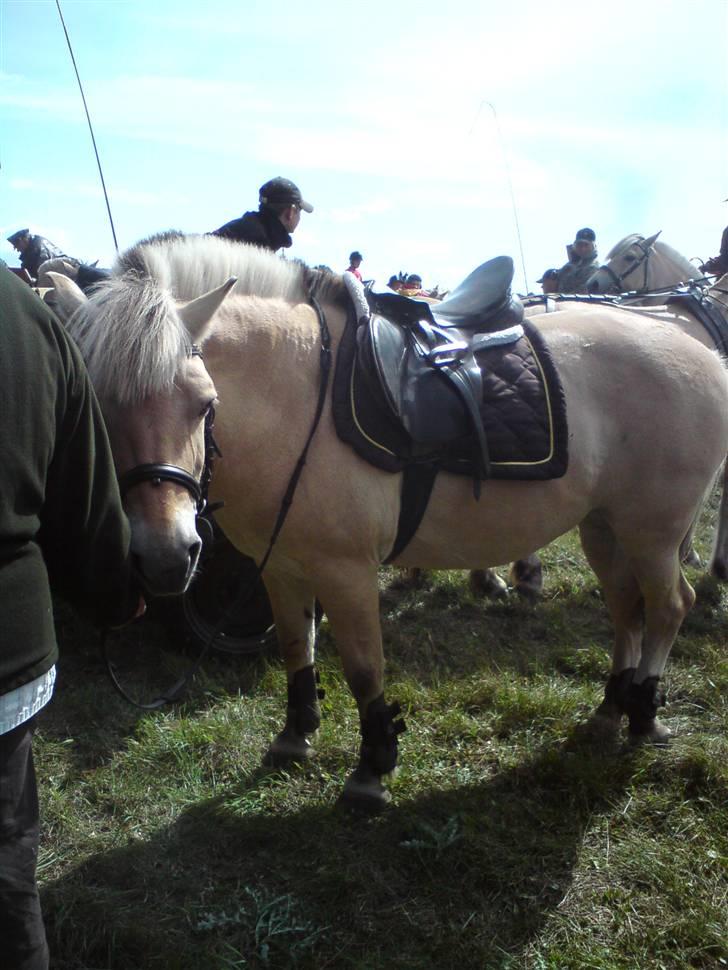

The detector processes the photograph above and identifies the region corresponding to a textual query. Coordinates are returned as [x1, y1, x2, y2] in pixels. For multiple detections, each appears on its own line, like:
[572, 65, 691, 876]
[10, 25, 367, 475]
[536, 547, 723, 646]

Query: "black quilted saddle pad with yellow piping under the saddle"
[332, 318, 568, 481]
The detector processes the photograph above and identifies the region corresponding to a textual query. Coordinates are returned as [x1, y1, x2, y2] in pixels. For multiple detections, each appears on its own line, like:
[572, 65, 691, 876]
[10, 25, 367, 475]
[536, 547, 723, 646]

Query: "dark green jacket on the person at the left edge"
[0, 260, 138, 694]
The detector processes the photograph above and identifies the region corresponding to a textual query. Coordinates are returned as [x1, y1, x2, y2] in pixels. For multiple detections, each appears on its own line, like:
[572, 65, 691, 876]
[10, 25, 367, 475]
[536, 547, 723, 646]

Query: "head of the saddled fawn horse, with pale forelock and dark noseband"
[54, 268, 235, 596]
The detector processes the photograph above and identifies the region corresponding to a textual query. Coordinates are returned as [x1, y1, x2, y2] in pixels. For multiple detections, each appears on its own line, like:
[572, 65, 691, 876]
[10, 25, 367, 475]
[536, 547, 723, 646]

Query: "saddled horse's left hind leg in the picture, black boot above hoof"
[579, 514, 644, 732]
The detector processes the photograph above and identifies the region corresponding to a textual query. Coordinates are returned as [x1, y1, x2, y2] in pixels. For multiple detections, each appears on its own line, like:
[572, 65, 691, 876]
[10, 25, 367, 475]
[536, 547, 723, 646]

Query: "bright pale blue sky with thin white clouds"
[0, 0, 728, 293]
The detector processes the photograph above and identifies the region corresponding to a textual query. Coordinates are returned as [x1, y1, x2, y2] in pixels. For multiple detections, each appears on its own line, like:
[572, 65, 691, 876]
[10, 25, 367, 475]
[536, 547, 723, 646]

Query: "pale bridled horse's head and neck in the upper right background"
[587, 232, 703, 298]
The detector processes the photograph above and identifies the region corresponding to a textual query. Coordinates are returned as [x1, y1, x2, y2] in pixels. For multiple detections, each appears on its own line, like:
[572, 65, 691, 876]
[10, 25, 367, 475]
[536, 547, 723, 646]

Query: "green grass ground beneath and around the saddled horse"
[36, 496, 728, 970]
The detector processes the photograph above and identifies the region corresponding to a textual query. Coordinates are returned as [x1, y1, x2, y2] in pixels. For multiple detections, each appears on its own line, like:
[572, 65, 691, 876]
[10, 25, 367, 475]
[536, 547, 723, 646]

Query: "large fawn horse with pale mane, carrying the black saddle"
[58, 236, 728, 807]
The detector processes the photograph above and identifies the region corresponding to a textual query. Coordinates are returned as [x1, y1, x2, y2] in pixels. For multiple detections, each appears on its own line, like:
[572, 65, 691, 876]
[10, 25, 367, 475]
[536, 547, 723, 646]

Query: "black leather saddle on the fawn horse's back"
[357, 256, 523, 495]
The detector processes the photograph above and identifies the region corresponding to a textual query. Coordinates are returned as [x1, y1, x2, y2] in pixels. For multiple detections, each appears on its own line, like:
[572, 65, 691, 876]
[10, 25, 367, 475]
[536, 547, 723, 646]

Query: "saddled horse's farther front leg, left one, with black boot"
[263, 574, 322, 767]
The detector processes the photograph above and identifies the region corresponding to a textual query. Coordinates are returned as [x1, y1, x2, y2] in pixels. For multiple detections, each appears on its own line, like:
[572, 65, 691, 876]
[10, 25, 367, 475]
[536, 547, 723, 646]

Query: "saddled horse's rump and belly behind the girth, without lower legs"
[397, 307, 728, 568]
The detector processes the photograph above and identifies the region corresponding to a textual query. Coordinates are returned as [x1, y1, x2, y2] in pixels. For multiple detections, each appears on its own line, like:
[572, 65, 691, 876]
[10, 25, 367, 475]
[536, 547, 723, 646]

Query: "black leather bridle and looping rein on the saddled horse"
[101, 288, 331, 711]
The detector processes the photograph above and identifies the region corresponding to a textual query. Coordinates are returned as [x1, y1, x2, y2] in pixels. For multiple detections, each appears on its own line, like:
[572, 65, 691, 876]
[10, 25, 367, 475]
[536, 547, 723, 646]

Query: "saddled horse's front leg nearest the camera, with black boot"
[317, 563, 404, 811]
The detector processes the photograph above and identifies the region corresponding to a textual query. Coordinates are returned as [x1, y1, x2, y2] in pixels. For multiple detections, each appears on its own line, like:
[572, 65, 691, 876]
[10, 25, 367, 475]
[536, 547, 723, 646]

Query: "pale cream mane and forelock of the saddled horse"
[68, 232, 347, 404]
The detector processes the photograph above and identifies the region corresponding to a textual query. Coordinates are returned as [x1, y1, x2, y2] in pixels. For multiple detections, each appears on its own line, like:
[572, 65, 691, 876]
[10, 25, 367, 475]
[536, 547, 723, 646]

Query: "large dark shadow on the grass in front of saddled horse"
[43, 739, 632, 970]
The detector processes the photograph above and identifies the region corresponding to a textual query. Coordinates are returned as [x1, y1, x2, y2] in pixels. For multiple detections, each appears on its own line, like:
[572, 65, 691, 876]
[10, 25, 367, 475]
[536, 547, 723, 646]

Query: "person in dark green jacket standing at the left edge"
[0, 267, 144, 970]
